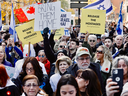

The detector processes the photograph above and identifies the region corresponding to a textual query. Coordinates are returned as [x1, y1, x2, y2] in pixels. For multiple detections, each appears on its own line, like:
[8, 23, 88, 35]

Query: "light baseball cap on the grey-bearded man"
[76, 47, 92, 58]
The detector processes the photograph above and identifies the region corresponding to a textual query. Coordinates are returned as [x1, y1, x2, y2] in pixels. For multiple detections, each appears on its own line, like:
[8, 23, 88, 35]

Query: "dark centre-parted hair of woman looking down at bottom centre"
[55, 74, 81, 96]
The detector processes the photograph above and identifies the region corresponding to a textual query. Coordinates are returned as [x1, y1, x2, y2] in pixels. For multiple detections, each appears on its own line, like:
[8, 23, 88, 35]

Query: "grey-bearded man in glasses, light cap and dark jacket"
[66, 47, 104, 90]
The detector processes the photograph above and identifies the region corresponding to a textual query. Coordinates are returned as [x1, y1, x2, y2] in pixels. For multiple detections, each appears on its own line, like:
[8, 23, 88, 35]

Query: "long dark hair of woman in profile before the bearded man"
[81, 68, 102, 96]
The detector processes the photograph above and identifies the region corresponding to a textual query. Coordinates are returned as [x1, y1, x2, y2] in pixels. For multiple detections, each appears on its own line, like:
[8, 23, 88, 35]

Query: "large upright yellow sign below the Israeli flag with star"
[80, 9, 106, 34]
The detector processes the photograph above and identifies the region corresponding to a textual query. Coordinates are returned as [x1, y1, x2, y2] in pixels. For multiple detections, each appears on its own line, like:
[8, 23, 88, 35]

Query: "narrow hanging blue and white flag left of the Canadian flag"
[9, 3, 18, 42]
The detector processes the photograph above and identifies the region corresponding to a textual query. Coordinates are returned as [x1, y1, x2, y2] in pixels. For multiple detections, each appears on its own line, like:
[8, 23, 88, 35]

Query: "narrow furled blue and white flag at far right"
[116, 1, 123, 35]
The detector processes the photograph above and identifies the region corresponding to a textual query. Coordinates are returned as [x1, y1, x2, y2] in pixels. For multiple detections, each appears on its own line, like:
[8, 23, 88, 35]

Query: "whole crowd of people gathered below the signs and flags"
[0, 23, 128, 96]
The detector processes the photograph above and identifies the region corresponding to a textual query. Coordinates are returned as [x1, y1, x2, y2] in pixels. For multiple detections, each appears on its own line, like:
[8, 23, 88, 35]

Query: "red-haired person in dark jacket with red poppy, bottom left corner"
[0, 64, 20, 96]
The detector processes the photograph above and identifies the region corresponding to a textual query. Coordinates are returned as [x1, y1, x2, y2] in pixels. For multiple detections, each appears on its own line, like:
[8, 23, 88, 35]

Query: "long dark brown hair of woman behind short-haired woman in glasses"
[20, 57, 43, 82]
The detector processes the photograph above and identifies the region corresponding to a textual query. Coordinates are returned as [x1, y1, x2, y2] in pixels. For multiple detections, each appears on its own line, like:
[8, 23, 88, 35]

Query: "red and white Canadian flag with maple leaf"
[14, 3, 40, 23]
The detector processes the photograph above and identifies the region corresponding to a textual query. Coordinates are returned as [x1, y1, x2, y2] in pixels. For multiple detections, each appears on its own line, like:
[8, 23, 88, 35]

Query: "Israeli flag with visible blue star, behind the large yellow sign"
[83, 0, 113, 16]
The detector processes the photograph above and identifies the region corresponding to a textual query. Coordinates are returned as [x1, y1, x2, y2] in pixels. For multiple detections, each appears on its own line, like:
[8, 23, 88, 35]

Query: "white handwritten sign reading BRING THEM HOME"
[34, 1, 61, 31]
